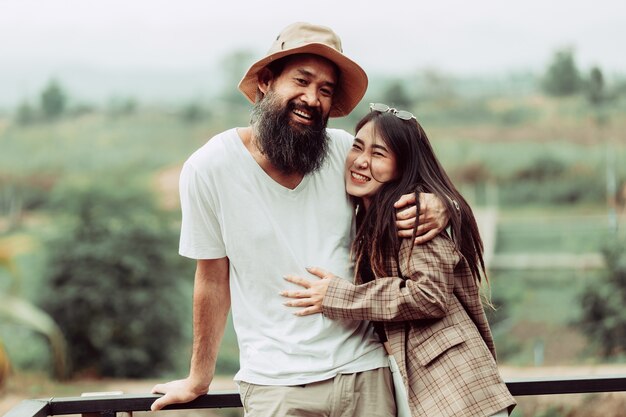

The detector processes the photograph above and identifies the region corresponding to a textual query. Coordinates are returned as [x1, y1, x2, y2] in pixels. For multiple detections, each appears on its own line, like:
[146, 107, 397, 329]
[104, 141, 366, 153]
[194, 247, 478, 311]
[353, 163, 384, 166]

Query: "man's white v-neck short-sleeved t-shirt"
[180, 129, 388, 385]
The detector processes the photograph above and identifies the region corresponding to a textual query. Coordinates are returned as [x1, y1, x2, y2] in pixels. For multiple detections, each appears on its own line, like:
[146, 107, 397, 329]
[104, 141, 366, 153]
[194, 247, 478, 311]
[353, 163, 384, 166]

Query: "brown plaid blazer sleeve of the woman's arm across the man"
[322, 237, 460, 321]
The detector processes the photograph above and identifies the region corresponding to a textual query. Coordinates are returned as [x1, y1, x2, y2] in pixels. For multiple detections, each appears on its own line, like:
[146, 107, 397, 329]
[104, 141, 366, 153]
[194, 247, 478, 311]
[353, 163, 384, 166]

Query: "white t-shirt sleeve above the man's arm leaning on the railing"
[178, 161, 226, 259]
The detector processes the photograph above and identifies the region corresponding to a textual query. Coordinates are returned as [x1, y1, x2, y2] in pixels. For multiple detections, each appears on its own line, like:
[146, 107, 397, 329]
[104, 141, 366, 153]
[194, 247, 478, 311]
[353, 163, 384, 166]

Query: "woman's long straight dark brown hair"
[352, 111, 487, 283]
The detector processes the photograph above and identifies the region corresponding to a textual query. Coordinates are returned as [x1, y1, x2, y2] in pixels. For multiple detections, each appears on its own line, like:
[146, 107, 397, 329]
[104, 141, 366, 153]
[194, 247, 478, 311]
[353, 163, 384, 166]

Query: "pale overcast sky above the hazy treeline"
[0, 0, 626, 105]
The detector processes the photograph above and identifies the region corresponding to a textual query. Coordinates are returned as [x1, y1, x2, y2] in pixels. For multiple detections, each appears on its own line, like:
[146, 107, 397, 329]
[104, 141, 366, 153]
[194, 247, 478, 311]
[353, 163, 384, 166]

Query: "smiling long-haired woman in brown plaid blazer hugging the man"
[281, 104, 515, 417]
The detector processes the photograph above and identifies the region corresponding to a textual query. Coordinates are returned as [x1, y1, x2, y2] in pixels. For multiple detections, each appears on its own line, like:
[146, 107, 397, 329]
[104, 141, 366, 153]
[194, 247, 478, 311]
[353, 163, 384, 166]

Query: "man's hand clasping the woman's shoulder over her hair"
[394, 193, 450, 245]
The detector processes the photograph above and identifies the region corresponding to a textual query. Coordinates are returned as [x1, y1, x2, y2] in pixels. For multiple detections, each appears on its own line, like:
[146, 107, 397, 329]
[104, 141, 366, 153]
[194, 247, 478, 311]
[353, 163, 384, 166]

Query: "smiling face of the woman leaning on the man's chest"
[345, 121, 398, 208]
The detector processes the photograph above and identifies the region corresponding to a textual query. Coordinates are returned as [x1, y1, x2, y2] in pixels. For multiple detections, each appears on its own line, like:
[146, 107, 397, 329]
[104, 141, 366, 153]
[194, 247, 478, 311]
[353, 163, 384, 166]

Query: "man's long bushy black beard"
[252, 91, 328, 175]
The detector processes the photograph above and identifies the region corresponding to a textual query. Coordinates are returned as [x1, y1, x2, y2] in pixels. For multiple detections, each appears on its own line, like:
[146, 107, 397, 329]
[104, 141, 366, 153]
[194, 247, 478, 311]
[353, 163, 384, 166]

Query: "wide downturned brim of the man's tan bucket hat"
[239, 43, 368, 117]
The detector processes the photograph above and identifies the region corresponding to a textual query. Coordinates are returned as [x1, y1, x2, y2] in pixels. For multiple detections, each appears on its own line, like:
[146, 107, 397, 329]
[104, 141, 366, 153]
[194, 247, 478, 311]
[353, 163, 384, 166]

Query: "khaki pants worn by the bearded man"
[239, 368, 396, 417]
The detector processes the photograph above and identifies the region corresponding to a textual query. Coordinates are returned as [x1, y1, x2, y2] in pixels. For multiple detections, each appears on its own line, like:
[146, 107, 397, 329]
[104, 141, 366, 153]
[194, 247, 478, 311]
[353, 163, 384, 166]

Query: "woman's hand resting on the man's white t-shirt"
[280, 267, 335, 316]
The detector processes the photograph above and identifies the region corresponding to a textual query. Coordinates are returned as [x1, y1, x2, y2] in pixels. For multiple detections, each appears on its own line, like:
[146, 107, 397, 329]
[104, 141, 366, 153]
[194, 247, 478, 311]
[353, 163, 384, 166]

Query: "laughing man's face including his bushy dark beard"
[253, 56, 336, 174]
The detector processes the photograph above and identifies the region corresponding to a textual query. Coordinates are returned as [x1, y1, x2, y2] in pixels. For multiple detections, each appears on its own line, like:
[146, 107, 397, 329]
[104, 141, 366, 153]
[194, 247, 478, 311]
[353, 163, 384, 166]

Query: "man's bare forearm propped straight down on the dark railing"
[151, 258, 230, 411]
